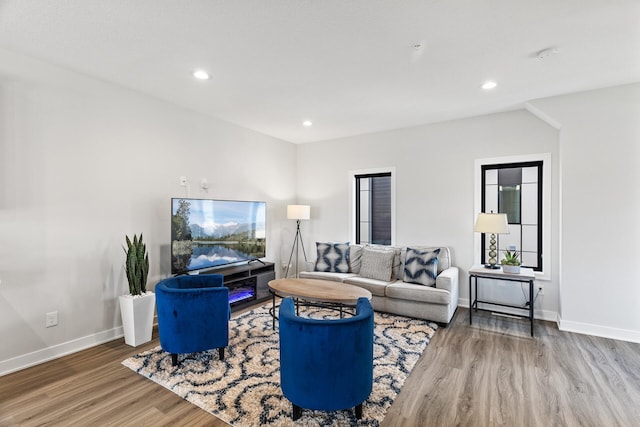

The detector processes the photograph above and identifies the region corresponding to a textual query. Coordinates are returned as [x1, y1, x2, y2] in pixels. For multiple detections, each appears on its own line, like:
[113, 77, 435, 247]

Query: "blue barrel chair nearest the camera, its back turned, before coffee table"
[278, 298, 373, 420]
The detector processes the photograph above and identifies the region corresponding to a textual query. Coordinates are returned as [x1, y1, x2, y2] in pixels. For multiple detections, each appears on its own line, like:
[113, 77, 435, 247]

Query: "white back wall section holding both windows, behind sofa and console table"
[297, 110, 559, 320]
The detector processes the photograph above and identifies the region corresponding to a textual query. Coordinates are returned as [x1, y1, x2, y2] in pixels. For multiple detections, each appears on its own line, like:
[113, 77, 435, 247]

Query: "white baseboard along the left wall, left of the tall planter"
[0, 326, 124, 376]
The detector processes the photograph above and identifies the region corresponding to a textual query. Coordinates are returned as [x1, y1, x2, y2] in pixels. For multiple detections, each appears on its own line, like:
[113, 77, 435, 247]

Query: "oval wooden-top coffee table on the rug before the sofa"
[269, 279, 371, 329]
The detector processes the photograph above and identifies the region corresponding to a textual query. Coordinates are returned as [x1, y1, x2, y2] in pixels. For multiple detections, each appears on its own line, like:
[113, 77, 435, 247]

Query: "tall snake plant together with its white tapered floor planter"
[120, 233, 156, 347]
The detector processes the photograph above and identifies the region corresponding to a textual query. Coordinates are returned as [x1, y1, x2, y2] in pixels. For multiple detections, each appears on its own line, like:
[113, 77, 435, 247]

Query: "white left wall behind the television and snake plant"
[0, 50, 296, 374]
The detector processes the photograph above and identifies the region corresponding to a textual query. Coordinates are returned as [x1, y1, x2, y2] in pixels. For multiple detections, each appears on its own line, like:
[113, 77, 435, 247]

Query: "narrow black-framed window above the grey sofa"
[355, 172, 392, 245]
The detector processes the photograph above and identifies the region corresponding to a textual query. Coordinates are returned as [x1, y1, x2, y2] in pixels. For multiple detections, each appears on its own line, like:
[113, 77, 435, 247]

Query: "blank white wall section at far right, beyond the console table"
[531, 84, 640, 342]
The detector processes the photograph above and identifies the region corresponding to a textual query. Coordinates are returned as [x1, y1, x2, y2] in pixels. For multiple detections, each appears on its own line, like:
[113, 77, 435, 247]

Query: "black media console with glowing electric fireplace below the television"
[200, 261, 276, 311]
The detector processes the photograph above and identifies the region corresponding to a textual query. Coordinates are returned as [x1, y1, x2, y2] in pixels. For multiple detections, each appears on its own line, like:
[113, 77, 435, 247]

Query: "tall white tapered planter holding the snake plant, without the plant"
[120, 292, 156, 347]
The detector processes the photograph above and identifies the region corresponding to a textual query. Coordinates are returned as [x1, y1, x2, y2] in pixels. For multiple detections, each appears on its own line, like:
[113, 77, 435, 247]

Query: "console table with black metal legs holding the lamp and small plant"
[469, 265, 535, 336]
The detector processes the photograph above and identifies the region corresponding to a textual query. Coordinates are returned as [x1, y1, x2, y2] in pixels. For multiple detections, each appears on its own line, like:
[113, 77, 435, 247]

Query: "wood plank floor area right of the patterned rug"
[382, 309, 640, 427]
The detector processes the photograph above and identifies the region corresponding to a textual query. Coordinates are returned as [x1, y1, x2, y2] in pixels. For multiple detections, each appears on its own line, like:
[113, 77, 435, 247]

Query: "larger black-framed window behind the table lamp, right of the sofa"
[481, 161, 544, 271]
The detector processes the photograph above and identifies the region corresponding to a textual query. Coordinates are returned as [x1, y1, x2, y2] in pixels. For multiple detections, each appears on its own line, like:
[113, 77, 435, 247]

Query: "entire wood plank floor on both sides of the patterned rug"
[0, 308, 640, 427]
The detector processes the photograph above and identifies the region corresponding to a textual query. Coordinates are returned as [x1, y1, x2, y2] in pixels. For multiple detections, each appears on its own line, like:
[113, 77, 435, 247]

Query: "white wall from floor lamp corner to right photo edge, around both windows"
[298, 84, 640, 342]
